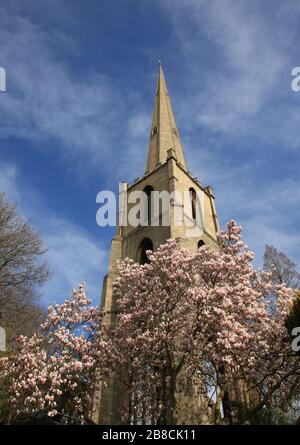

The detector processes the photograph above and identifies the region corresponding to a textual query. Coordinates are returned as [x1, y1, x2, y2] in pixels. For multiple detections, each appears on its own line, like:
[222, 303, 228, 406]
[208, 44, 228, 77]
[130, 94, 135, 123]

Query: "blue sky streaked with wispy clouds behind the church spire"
[0, 0, 300, 304]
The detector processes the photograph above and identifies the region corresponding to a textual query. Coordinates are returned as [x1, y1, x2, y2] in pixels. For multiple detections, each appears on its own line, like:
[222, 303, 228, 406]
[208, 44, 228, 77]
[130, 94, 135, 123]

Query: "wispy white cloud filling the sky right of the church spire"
[157, 0, 300, 264]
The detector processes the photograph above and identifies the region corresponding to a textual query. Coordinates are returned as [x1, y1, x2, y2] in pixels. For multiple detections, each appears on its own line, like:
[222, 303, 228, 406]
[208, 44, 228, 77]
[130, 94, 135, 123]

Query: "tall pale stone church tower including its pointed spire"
[95, 63, 219, 425]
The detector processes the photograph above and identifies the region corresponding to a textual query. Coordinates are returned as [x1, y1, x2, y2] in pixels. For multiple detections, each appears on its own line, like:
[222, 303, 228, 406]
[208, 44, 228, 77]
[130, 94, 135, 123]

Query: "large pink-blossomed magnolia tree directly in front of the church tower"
[112, 221, 300, 424]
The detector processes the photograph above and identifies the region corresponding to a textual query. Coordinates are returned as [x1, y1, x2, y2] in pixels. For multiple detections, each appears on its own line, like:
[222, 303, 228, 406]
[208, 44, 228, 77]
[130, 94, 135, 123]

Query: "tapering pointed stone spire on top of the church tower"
[146, 61, 187, 173]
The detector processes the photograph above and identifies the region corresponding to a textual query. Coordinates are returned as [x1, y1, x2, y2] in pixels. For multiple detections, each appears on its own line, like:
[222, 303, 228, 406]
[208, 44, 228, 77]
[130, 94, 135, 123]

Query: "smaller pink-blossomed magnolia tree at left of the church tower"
[2, 284, 105, 419]
